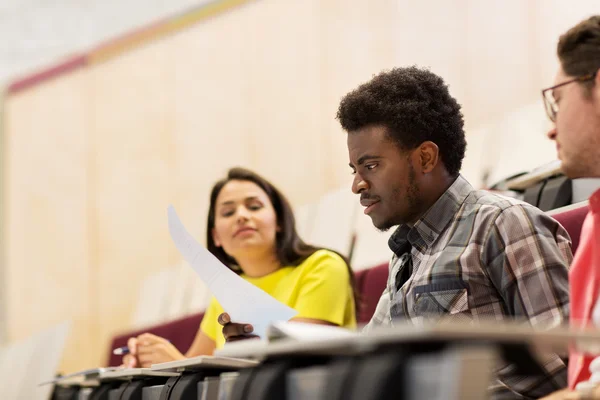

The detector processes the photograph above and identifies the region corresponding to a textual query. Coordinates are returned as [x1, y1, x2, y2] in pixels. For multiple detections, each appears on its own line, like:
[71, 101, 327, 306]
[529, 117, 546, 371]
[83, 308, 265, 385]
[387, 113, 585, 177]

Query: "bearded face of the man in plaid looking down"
[347, 125, 419, 230]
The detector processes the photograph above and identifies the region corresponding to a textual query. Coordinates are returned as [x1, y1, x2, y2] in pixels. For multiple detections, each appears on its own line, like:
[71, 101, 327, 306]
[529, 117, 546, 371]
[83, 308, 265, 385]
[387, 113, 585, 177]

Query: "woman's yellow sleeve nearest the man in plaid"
[294, 250, 353, 326]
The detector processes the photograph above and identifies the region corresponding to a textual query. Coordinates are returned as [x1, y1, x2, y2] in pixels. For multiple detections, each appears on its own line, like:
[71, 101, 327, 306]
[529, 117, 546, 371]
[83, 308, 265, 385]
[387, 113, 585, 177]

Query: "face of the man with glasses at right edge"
[548, 68, 600, 178]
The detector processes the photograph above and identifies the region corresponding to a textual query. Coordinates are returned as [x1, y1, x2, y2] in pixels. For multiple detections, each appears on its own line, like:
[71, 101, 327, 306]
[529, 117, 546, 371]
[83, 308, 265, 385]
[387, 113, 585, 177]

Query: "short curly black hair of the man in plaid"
[337, 66, 467, 176]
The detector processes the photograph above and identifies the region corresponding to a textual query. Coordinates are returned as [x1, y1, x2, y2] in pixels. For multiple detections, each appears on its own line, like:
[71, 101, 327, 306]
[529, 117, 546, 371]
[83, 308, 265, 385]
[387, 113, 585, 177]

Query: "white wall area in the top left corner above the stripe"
[0, 0, 211, 83]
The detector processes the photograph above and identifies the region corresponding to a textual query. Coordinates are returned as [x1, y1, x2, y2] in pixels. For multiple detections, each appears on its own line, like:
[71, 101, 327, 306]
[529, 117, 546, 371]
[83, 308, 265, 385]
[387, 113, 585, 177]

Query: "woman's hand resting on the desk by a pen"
[123, 333, 185, 368]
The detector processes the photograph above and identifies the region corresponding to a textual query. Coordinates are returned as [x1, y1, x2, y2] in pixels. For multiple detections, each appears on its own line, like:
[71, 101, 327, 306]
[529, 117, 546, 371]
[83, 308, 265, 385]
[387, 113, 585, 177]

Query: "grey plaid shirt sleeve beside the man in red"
[482, 205, 573, 398]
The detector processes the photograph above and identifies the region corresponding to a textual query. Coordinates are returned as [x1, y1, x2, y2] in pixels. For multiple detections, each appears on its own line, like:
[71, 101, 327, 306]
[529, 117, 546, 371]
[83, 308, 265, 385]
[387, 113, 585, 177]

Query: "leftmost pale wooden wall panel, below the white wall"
[3, 70, 92, 370]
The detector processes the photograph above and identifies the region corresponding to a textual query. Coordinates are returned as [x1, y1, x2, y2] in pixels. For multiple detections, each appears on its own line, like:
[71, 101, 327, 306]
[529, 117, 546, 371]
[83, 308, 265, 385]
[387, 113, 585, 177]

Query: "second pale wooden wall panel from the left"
[89, 36, 174, 351]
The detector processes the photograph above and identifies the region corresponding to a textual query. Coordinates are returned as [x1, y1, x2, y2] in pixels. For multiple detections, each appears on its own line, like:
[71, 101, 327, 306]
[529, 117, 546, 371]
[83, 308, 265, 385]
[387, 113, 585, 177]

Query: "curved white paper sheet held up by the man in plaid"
[168, 206, 298, 338]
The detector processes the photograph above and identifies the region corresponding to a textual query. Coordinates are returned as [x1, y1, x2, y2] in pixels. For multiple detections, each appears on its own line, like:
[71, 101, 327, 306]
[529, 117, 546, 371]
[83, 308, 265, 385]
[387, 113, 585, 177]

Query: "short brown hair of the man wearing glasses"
[556, 15, 600, 88]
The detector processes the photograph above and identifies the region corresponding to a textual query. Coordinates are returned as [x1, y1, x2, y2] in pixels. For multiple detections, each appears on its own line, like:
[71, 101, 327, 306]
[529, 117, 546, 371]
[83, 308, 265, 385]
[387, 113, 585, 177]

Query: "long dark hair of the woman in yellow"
[206, 167, 360, 314]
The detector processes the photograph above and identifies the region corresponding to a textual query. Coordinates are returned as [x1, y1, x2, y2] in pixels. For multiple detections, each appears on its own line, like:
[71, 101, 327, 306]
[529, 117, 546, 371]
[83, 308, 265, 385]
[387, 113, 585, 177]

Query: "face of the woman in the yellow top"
[212, 180, 279, 259]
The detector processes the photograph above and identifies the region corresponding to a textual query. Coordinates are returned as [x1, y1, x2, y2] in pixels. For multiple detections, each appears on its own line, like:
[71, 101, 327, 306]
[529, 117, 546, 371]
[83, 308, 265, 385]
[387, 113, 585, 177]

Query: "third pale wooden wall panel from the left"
[169, 4, 253, 247]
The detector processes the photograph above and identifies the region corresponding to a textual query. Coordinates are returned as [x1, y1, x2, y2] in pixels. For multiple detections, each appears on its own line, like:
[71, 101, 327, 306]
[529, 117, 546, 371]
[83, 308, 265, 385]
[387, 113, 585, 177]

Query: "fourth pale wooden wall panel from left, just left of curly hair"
[245, 0, 332, 204]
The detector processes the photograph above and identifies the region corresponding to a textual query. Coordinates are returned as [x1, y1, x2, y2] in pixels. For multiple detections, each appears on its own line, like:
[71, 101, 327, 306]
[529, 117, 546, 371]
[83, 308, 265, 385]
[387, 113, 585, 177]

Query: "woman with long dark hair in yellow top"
[123, 168, 356, 367]
